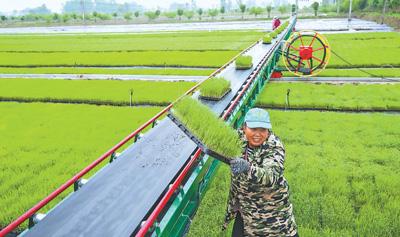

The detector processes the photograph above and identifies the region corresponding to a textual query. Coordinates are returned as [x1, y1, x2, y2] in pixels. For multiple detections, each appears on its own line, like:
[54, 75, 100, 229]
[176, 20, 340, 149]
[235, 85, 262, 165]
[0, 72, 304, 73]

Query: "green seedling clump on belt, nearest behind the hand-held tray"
[200, 77, 231, 100]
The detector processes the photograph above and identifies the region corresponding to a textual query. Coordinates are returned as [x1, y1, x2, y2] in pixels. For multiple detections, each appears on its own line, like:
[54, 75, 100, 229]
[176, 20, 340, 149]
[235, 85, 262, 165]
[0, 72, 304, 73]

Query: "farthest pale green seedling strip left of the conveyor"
[0, 31, 263, 53]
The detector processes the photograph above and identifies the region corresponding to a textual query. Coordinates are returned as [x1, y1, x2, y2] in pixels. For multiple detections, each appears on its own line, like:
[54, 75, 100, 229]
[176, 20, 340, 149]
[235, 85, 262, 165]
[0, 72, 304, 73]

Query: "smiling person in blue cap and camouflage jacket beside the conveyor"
[222, 108, 298, 237]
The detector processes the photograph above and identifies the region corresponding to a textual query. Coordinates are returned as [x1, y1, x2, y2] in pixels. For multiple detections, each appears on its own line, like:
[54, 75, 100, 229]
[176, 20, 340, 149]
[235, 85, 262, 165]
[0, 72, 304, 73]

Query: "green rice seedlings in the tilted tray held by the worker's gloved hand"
[172, 96, 242, 158]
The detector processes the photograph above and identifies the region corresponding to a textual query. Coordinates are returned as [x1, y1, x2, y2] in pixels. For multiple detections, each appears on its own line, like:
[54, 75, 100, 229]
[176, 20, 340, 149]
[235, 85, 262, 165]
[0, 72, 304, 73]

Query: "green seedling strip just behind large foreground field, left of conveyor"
[0, 79, 195, 105]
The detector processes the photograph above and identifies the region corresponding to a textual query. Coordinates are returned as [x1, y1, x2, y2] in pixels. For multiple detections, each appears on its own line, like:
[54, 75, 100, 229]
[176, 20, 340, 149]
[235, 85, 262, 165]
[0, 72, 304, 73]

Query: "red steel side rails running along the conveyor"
[0, 39, 261, 237]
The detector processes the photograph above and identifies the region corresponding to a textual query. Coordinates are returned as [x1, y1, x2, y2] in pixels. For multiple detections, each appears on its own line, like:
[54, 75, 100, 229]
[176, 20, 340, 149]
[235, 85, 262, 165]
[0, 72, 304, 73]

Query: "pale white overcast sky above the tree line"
[0, 0, 265, 12]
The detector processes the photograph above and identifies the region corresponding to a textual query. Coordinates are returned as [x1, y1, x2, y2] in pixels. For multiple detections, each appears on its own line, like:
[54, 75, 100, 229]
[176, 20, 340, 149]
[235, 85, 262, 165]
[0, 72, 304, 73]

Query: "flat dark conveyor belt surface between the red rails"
[24, 32, 286, 237]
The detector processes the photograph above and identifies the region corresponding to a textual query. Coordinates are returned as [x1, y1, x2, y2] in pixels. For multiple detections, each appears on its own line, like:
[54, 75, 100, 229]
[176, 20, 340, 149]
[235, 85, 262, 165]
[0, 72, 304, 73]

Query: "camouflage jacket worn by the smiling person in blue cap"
[223, 131, 297, 237]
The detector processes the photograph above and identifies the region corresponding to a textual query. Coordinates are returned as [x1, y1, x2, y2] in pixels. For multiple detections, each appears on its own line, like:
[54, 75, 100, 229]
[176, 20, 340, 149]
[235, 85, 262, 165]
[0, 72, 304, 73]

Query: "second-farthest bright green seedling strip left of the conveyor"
[0, 50, 240, 68]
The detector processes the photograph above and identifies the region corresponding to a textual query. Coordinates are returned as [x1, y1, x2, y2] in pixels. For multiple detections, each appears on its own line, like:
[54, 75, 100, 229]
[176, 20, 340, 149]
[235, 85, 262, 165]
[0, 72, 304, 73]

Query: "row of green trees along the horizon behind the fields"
[0, 0, 400, 23]
